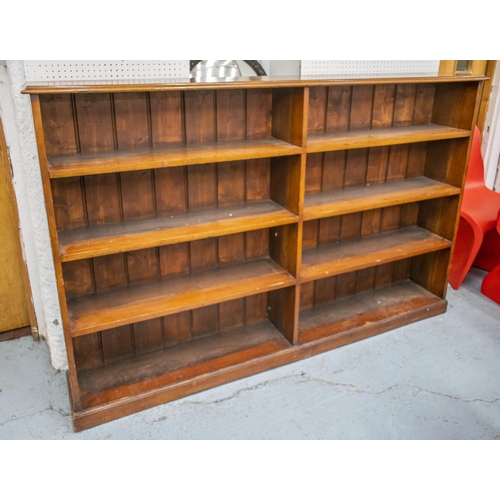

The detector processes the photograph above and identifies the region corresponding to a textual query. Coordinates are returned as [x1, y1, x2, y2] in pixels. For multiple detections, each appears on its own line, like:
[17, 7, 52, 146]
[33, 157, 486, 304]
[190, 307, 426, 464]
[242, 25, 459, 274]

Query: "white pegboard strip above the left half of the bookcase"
[24, 61, 189, 82]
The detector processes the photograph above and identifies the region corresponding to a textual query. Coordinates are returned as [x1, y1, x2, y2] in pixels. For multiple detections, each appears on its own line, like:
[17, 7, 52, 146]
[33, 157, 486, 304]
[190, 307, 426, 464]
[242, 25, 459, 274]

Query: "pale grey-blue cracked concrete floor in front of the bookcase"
[0, 269, 500, 440]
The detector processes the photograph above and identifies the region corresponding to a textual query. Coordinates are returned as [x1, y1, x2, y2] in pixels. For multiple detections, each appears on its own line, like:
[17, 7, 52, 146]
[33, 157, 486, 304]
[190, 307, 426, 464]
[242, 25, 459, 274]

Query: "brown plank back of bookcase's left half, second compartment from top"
[51, 158, 280, 230]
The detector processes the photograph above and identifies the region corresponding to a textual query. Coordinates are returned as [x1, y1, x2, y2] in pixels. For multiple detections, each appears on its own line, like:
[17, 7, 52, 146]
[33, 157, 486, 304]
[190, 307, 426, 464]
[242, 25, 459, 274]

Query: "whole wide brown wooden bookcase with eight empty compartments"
[24, 73, 484, 430]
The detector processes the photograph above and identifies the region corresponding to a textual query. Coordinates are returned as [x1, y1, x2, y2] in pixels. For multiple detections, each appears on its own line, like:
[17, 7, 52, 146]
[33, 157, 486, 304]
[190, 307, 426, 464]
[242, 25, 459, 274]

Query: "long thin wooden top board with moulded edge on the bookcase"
[22, 75, 488, 94]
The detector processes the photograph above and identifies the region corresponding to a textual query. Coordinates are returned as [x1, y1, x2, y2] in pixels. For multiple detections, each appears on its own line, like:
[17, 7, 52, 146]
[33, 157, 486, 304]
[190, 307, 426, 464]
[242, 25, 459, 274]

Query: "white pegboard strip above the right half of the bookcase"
[300, 60, 439, 78]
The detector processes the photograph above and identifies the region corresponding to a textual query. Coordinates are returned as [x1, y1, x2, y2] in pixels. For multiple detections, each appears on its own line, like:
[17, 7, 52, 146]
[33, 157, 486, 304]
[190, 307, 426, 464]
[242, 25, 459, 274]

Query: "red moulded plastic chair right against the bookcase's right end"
[449, 126, 500, 290]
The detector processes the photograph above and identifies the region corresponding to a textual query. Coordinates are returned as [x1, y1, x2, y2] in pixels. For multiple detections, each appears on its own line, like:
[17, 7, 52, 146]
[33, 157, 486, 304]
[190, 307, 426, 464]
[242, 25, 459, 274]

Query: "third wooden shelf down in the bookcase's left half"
[68, 259, 294, 337]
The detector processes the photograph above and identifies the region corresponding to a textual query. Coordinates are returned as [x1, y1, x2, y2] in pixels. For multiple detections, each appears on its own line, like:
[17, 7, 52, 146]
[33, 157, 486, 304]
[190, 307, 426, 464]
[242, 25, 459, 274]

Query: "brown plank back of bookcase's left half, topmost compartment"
[40, 89, 282, 155]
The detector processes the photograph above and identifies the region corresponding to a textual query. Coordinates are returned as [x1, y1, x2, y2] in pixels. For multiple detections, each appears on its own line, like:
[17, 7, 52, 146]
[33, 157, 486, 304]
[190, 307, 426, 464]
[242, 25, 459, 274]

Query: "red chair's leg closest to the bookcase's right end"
[449, 217, 483, 290]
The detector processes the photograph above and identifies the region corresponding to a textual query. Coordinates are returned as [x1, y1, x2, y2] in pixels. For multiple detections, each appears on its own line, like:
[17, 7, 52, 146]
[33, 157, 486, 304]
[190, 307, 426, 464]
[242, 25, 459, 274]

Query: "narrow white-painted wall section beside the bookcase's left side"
[0, 61, 67, 369]
